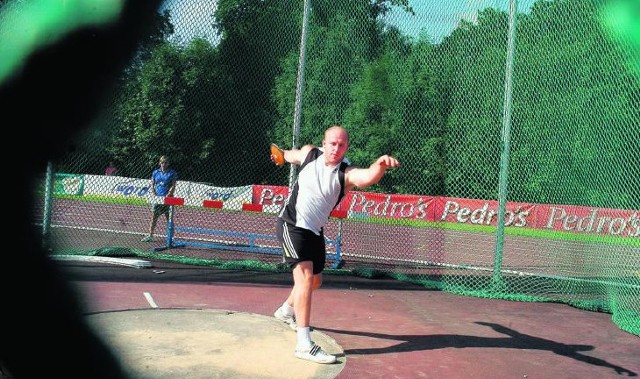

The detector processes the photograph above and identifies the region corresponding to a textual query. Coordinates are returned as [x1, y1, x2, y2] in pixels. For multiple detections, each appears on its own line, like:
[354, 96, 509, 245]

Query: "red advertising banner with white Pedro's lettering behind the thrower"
[253, 185, 640, 237]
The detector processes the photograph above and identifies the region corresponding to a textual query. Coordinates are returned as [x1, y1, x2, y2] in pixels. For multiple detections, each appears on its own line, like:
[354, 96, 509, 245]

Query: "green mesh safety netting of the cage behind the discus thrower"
[12, 0, 640, 335]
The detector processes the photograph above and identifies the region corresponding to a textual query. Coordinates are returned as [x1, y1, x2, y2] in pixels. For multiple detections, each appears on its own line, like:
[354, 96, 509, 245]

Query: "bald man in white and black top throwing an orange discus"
[271, 125, 400, 363]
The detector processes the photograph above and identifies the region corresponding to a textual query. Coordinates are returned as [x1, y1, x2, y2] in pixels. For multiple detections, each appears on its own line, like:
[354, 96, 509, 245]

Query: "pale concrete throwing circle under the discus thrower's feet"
[87, 309, 346, 379]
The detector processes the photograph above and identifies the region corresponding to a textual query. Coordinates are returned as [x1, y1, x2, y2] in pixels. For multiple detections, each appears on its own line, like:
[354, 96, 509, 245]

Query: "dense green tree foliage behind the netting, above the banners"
[61, 0, 640, 208]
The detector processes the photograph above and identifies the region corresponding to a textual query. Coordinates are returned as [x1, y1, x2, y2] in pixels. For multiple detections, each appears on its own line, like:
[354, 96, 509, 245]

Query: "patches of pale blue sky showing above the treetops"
[161, 0, 535, 43]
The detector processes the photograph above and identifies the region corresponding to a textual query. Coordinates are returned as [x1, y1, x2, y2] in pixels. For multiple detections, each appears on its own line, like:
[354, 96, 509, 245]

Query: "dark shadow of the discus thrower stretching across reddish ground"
[316, 321, 638, 376]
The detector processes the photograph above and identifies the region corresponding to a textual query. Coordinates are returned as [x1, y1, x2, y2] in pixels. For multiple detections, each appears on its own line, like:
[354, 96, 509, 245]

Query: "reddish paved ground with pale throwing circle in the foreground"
[38, 262, 640, 379]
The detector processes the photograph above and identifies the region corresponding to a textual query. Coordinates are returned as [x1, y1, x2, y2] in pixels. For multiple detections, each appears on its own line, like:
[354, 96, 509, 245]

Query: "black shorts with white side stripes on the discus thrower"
[276, 217, 327, 274]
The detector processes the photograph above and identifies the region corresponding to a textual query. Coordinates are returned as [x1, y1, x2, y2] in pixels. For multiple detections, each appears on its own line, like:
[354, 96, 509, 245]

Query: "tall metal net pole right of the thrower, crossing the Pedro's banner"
[492, 0, 517, 289]
